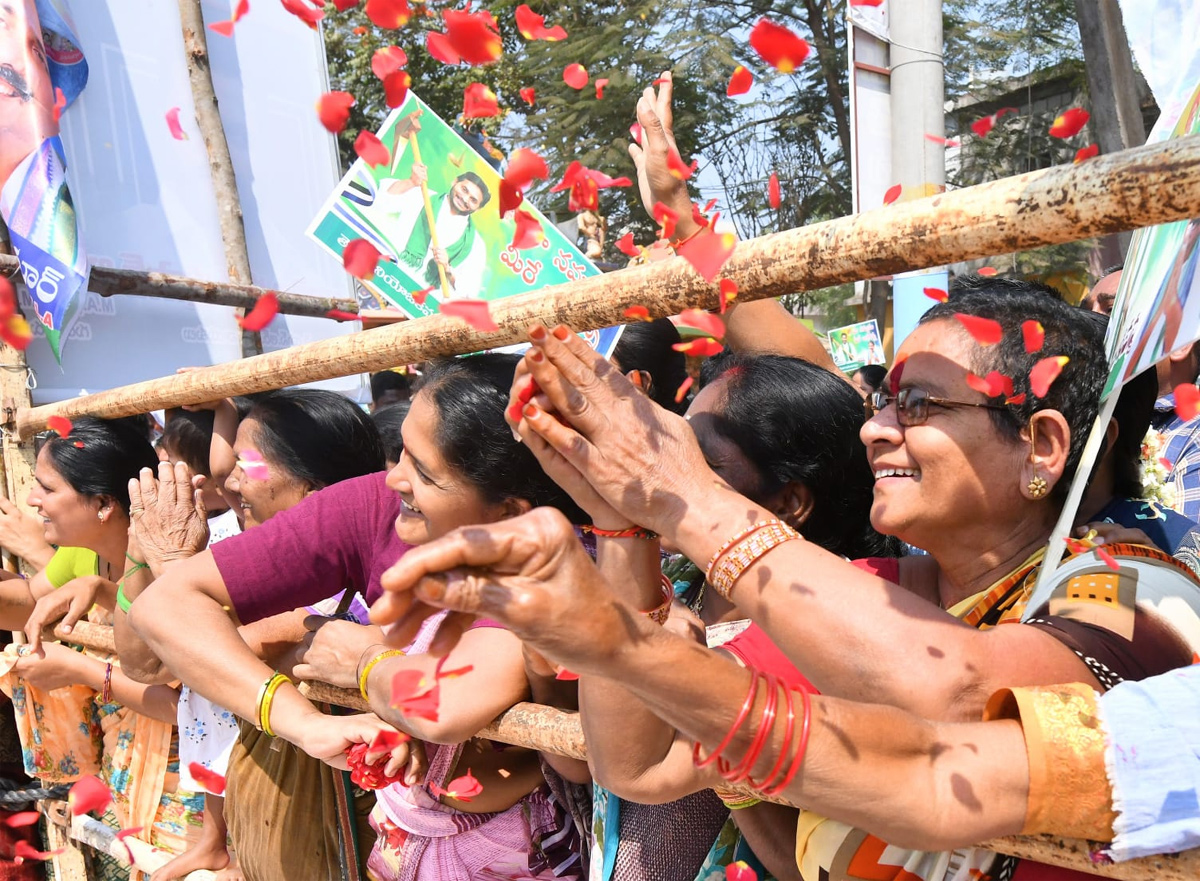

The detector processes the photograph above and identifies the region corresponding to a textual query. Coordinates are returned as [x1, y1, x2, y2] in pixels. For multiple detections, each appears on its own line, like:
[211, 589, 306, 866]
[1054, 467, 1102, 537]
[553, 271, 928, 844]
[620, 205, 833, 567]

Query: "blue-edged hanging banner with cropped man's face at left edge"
[0, 0, 88, 361]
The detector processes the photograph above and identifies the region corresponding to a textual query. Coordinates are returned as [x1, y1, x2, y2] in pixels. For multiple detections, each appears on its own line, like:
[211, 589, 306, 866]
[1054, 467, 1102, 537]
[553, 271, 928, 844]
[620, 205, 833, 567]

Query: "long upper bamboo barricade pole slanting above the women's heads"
[17, 134, 1200, 437]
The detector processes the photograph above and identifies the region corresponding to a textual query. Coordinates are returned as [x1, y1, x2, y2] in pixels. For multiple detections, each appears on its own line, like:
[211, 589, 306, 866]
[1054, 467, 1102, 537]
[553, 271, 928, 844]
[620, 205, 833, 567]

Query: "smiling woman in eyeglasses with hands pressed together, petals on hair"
[396, 280, 1200, 881]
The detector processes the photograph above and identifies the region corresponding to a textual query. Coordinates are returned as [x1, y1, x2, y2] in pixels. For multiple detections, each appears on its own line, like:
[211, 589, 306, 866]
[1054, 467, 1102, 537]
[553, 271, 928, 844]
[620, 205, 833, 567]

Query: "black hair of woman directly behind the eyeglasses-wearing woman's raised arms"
[706, 353, 899, 558]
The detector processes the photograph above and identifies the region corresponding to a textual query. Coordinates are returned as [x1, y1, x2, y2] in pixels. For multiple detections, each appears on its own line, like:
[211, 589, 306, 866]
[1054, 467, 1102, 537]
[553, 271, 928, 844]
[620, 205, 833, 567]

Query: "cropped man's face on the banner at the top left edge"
[0, 0, 58, 160]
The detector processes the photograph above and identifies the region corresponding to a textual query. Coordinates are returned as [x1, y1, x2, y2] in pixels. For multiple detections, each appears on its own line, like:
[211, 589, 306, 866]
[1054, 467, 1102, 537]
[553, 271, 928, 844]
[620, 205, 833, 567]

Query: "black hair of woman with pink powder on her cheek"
[246, 389, 383, 490]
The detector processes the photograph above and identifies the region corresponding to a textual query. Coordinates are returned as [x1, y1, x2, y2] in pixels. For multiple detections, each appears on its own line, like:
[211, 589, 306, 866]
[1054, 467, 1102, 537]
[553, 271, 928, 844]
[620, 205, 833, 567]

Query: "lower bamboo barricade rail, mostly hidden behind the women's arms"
[54, 621, 1200, 881]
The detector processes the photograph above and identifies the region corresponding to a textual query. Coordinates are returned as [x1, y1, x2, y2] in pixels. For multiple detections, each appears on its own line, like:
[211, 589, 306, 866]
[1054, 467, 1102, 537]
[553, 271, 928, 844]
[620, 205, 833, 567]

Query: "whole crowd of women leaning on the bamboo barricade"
[0, 77, 1200, 881]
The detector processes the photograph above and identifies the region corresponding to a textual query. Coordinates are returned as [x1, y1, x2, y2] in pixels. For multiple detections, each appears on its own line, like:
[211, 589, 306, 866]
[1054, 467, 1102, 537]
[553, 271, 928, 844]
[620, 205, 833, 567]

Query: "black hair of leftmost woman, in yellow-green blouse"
[42, 416, 158, 514]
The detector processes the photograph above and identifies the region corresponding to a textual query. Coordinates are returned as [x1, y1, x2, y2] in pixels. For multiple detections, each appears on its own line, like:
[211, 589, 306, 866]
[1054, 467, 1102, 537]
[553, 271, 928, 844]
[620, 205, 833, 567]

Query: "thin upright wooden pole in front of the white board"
[179, 0, 263, 358]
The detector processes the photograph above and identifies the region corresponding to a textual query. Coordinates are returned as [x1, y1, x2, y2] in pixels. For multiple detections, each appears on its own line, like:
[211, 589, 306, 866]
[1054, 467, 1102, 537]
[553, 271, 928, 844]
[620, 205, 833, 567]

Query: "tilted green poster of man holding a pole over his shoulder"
[308, 92, 619, 354]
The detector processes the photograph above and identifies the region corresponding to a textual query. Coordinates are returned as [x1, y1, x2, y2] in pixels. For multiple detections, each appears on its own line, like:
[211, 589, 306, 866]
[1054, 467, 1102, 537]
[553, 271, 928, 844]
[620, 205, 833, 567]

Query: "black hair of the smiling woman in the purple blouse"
[419, 353, 592, 525]
